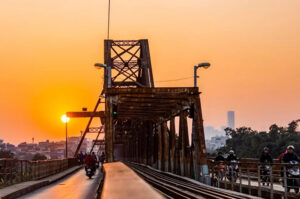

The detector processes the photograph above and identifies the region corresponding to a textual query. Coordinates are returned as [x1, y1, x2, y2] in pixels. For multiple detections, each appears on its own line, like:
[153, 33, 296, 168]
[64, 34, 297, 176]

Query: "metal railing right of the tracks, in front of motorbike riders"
[209, 159, 300, 199]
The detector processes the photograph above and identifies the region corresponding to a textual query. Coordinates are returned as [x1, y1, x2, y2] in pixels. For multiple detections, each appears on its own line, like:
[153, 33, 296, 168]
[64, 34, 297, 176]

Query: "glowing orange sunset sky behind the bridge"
[0, 0, 300, 143]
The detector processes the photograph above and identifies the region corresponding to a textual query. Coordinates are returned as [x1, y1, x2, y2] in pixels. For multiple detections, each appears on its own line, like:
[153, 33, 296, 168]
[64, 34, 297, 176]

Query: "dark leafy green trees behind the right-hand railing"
[217, 119, 300, 159]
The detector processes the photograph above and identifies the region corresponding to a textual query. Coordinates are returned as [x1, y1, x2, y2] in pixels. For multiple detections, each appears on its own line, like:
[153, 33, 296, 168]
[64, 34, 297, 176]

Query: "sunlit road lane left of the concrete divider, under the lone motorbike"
[18, 169, 102, 199]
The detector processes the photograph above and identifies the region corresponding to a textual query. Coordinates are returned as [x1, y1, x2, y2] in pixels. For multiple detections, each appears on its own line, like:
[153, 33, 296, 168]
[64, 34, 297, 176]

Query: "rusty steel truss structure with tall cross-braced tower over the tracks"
[67, 39, 208, 180]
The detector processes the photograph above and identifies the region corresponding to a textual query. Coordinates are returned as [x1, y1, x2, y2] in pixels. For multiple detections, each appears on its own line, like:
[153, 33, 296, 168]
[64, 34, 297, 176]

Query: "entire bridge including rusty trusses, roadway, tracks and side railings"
[0, 39, 298, 198]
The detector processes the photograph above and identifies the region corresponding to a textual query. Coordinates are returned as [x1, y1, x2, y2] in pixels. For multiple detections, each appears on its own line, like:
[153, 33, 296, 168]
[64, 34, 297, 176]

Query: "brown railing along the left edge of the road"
[0, 158, 77, 188]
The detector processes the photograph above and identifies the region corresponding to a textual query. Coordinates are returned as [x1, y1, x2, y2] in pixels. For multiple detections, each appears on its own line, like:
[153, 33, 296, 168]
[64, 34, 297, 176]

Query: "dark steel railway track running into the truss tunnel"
[125, 162, 253, 199]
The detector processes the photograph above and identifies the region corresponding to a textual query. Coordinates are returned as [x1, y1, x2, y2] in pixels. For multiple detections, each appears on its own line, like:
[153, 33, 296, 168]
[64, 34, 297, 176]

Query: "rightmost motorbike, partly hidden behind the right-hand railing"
[286, 160, 300, 193]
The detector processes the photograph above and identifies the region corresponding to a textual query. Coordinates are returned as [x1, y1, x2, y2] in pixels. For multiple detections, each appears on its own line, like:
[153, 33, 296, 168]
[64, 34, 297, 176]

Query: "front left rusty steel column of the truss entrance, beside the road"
[105, 96, 114, 162]
